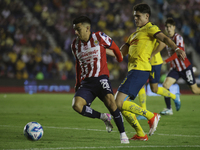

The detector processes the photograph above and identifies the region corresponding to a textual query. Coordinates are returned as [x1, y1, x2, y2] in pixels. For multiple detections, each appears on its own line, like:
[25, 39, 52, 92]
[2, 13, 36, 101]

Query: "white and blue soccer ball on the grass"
[24, 122, 43, 141]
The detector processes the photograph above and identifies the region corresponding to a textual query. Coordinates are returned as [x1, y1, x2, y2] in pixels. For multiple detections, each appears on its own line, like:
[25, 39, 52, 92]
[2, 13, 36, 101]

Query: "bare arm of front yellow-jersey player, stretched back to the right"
[155, 32, 186, 60]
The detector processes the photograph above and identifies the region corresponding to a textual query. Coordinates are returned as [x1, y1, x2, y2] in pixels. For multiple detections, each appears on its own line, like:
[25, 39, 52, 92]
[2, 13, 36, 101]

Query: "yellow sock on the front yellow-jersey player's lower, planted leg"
[122, 111, 145, 136]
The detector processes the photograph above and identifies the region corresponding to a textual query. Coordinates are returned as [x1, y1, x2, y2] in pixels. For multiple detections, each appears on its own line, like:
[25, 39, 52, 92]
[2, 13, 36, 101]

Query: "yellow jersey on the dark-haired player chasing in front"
[126, 22, 161, 71]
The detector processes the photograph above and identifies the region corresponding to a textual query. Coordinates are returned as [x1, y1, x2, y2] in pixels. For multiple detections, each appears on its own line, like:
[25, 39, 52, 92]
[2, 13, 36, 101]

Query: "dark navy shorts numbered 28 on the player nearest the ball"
[74, 75, 113, 106]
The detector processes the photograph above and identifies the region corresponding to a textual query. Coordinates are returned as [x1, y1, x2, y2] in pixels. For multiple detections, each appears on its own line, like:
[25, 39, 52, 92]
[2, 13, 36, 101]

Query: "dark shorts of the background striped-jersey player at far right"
[167, 65, 196, 85]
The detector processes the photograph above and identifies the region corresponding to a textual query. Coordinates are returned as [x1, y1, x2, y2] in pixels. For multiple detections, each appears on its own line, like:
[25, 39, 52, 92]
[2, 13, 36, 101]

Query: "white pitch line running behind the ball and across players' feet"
[0, 125, 200, 138]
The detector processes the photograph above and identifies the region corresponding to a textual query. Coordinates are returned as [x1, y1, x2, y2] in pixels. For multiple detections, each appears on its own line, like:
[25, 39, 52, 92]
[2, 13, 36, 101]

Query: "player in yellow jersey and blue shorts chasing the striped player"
[115, 3, 186, 141]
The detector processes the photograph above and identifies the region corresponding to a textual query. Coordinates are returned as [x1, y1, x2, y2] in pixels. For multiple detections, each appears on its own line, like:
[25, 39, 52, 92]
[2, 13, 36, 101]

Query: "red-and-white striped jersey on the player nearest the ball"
[71, 32, 123, 86]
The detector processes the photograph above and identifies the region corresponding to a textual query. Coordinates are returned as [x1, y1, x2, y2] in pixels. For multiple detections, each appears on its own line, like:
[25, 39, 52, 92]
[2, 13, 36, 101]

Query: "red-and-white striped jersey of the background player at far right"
[165, 33, 191, 71]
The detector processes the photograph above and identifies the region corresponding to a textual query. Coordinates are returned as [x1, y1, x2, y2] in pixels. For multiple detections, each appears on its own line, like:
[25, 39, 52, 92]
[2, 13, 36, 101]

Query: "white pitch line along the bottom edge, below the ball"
[3, 145, 200, 150]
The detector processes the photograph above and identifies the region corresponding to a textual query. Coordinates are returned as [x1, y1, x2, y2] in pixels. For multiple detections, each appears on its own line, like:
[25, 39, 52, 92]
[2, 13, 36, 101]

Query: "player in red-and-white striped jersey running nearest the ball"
[71, 16, 129, 144]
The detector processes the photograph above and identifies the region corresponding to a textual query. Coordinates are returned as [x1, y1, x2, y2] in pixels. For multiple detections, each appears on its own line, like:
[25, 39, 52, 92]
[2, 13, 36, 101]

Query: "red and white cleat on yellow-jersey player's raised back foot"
[148, 113, 161, 136]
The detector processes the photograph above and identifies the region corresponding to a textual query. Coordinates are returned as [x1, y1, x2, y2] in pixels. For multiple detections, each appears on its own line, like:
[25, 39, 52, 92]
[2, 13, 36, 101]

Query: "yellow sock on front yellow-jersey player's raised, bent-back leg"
[122, 101, 154, 120]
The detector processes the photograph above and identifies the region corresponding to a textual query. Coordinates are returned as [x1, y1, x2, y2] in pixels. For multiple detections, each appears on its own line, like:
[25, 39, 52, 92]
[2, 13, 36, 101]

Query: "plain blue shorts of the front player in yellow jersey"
[118, 70, 150, 100]
